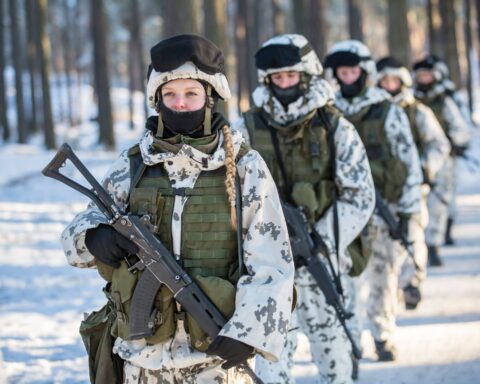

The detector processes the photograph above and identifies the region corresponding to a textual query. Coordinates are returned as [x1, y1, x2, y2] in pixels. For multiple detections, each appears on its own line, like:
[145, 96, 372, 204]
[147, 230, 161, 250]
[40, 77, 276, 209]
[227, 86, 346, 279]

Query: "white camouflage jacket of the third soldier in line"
[335, 87, 423, 214]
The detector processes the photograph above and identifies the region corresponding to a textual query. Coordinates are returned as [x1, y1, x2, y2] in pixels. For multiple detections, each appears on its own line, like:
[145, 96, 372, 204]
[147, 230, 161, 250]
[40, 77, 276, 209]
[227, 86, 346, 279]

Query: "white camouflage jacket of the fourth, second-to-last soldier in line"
[392, 88, 451, 180]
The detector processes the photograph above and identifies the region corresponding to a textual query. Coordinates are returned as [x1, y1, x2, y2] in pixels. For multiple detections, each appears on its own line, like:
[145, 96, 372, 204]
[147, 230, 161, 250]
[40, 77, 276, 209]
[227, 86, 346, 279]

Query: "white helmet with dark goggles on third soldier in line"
[324, 40, 377, 77]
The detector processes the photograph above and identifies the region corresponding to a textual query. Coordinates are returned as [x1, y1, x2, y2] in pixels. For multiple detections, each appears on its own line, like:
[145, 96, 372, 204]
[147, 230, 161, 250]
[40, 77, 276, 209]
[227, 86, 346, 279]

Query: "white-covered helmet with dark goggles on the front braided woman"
[147, 35, 231, 108]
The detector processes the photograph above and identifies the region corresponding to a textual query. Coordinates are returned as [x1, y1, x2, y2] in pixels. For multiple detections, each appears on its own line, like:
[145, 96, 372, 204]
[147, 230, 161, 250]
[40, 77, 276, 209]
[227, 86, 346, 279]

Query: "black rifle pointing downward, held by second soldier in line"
[282, 202, 362, 359]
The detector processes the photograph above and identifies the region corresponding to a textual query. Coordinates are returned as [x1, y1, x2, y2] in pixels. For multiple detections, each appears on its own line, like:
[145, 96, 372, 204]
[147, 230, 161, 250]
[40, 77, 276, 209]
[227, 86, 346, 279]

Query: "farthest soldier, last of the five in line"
[413, 55, 470, 266]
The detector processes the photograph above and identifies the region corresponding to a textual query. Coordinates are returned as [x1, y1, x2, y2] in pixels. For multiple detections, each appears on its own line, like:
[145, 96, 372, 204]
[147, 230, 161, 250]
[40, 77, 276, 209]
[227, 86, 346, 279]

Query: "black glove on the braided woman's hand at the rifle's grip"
[85, 224, 139, 268]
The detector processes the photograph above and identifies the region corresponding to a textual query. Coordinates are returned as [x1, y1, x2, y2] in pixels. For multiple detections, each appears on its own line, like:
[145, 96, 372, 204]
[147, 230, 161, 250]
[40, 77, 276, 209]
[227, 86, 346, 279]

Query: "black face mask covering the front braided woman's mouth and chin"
[158, 102, 205, 136]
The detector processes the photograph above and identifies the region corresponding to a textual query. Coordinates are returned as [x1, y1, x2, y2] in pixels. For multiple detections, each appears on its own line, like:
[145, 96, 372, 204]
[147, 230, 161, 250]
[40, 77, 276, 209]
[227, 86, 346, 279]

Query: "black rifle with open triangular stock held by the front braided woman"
[42, 143, 263, 384]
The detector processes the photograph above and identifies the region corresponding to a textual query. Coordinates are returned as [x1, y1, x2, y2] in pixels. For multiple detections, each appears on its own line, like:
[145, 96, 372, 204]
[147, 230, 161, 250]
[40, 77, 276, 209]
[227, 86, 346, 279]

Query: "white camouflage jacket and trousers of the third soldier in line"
[336, 87, 423, 340]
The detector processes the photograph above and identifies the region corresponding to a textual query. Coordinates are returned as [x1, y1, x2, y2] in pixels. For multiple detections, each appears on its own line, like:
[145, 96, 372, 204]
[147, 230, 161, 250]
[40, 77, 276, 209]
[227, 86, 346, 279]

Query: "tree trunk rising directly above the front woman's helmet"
[163, 0, 201, 37]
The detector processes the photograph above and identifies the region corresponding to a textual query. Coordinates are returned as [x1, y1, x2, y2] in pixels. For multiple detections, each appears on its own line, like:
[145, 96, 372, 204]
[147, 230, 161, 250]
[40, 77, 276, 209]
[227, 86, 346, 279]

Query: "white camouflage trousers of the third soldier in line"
[362, 214, 407, 341]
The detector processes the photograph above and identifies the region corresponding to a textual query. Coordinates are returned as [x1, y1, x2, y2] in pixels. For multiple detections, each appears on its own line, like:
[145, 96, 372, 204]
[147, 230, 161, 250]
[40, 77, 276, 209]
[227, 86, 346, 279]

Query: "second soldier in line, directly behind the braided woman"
[235, 34, 374, 384]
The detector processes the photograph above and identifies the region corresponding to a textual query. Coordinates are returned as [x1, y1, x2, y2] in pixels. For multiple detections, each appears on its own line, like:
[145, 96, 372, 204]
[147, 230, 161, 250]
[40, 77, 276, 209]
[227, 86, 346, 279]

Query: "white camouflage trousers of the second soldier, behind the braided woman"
[255, 267, 352, 384]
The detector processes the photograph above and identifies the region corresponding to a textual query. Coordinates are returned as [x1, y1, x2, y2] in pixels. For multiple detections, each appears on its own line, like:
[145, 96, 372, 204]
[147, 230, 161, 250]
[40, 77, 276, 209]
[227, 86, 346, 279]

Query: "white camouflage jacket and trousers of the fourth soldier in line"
[392, 88, 450, 287]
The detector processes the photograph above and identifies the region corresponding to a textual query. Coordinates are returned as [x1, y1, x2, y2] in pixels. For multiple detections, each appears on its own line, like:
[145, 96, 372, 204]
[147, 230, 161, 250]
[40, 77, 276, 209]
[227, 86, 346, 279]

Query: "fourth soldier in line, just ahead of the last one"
[377, 57, 450, 309]
